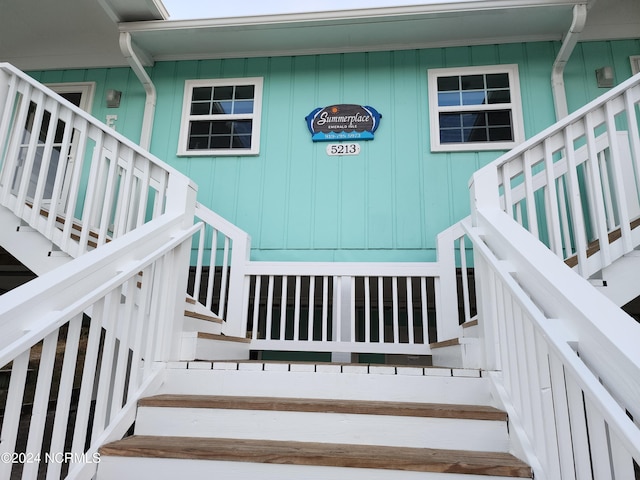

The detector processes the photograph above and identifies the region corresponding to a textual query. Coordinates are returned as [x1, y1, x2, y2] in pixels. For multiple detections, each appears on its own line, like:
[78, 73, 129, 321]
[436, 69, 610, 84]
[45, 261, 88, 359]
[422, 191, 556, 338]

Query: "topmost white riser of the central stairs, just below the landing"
[157, 365, 492, 405]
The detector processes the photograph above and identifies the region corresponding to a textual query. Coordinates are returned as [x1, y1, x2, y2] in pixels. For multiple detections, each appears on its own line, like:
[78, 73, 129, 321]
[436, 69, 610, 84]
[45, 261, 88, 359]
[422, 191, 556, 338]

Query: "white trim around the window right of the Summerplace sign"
[427, 64, 524, 152]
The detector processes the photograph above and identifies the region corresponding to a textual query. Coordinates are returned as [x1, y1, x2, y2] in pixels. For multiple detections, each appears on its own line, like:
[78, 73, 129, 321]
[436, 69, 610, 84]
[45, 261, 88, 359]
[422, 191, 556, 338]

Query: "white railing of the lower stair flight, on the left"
[0, 215, 200, 479]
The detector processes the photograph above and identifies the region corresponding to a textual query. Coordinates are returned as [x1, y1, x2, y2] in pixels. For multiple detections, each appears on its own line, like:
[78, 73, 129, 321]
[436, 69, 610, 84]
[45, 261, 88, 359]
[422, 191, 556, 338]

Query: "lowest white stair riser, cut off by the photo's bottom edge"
[97, 456, 528, 480]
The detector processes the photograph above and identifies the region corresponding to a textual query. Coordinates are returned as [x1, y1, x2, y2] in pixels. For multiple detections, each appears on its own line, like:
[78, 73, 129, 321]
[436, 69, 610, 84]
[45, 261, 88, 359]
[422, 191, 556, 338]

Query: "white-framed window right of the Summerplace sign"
[428, 65, 524, 152]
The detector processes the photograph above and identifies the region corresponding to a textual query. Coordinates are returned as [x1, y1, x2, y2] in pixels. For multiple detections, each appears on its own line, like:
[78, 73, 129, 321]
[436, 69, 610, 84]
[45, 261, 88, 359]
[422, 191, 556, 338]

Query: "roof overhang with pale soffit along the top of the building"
[0, 0, 640, 70]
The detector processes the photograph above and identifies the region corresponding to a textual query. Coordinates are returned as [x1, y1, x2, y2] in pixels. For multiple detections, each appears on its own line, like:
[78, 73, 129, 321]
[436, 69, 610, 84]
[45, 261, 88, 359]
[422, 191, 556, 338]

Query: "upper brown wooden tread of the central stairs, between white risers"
[138, 394, 507, 421]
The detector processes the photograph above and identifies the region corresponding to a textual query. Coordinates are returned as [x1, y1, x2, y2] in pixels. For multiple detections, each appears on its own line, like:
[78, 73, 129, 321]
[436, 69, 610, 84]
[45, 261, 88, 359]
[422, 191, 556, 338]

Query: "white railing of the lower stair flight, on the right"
[465, 209, 640, 479]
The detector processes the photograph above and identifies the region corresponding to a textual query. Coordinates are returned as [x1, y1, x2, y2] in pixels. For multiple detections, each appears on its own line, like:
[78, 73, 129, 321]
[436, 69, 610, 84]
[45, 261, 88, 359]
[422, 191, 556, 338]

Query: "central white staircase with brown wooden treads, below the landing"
[97, 362, 532, 480]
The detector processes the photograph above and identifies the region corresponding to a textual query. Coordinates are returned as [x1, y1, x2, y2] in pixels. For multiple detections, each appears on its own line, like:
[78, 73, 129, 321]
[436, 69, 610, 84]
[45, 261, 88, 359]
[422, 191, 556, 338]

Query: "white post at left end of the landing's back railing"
[224, 235, 251, 338]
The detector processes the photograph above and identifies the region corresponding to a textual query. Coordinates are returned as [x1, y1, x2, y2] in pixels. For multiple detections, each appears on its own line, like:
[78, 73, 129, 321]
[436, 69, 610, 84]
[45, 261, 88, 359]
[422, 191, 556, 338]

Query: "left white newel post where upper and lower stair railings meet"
[161, 174, 197, 360]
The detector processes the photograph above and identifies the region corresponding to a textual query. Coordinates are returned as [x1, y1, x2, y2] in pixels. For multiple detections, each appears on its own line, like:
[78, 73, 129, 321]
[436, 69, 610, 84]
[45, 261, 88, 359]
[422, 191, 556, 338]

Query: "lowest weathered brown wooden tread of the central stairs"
[100, 436, 532, 478]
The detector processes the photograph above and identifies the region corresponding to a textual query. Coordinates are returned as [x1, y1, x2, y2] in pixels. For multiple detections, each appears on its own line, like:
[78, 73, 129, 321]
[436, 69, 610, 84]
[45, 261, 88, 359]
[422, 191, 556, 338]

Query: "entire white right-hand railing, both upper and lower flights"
[465, 72, 640, 480]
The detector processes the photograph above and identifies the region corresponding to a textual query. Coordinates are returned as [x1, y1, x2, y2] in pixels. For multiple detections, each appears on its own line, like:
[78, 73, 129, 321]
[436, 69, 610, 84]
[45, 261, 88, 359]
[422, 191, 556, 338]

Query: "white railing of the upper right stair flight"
[474, 75, 640, 278]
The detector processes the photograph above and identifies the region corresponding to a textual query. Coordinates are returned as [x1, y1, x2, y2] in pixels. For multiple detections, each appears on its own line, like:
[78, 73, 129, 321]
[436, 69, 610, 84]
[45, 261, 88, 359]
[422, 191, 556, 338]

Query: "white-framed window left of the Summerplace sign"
[178, 78, 262, 155]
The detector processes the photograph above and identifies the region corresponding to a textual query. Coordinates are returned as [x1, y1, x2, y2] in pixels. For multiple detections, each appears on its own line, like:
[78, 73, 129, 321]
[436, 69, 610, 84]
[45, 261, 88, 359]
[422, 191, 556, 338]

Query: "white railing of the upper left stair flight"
[0, 64, 195, 258]
